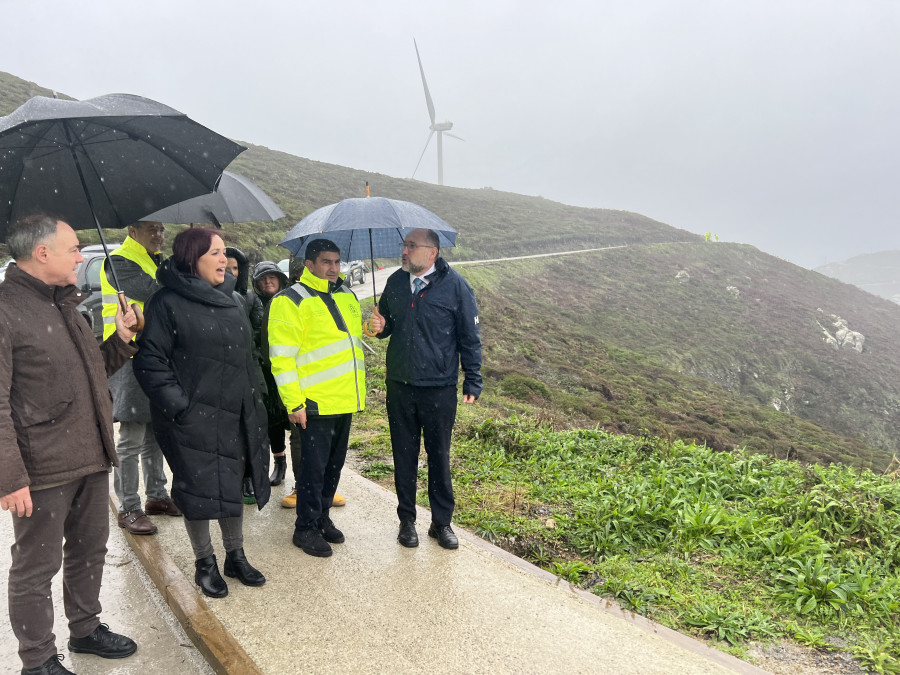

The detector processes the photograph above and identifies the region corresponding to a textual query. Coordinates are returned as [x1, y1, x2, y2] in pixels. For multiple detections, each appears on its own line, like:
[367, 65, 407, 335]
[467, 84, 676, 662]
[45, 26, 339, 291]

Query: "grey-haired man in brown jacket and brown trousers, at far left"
[0, 214, 137, 675]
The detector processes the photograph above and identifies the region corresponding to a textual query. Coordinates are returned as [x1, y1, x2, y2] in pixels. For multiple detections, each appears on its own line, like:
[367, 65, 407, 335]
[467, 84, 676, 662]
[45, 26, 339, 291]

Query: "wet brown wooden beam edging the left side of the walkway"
[109, 494, 263, 675]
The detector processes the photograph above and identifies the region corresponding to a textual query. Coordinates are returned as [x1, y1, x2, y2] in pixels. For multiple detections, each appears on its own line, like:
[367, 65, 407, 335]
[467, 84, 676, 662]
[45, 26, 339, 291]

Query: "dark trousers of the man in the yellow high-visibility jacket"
[291, 413, 353, 530]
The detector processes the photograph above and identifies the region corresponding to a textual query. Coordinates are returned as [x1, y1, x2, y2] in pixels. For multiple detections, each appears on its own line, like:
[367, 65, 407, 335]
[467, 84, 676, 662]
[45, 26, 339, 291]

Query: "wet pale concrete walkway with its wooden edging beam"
[128, 470, 763, 675]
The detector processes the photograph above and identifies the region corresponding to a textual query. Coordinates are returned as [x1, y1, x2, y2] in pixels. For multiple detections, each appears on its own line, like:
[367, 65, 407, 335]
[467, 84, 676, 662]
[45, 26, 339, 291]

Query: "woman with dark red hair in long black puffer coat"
[134, 228, 269, 597]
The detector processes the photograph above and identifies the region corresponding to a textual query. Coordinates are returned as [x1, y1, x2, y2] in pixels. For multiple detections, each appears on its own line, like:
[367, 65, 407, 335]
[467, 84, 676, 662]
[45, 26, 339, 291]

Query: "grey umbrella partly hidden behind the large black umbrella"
[142, 171, 284, 226]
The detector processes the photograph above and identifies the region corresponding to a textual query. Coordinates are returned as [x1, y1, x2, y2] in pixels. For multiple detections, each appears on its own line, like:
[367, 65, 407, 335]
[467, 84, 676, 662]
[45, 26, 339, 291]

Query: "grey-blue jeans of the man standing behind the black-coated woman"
[113, 422, 169, 513]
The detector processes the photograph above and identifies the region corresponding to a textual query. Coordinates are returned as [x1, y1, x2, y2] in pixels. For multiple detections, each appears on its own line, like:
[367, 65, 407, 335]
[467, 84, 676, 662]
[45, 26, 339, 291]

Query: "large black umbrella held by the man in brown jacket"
[0, 94, 246, 294]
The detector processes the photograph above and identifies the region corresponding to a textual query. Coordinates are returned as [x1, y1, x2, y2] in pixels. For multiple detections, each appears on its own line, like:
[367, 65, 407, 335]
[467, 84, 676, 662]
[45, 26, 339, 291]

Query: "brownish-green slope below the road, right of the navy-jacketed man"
[460, 243, 900, 469]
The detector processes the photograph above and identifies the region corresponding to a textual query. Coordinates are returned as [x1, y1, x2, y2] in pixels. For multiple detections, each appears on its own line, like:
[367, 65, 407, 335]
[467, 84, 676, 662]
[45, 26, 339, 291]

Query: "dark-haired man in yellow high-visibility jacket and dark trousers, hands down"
[267, 239, 366, 557]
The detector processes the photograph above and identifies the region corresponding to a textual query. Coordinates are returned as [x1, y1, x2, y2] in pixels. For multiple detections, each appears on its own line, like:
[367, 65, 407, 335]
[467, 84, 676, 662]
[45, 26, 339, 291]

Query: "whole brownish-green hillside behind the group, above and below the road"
[0, 74, 900, 468]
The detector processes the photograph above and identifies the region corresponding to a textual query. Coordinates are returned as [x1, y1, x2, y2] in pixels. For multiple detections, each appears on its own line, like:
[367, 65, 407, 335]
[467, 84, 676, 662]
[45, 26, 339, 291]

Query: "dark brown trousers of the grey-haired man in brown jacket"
[9, 471, 109, 668]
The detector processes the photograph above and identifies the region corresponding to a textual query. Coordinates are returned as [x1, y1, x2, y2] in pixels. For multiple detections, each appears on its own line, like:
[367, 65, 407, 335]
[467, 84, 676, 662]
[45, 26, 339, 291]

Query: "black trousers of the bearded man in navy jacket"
[387, 380, 457, 525]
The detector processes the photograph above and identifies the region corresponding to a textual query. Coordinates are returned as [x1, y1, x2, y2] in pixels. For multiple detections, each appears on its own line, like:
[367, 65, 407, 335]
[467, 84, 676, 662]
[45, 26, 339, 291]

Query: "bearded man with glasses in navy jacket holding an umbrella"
[371, 229, 481, 548]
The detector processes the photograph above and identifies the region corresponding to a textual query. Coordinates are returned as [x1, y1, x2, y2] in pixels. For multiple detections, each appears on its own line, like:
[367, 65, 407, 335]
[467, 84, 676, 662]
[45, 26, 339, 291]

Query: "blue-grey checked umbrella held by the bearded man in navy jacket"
[279, 197, 457, 300]
